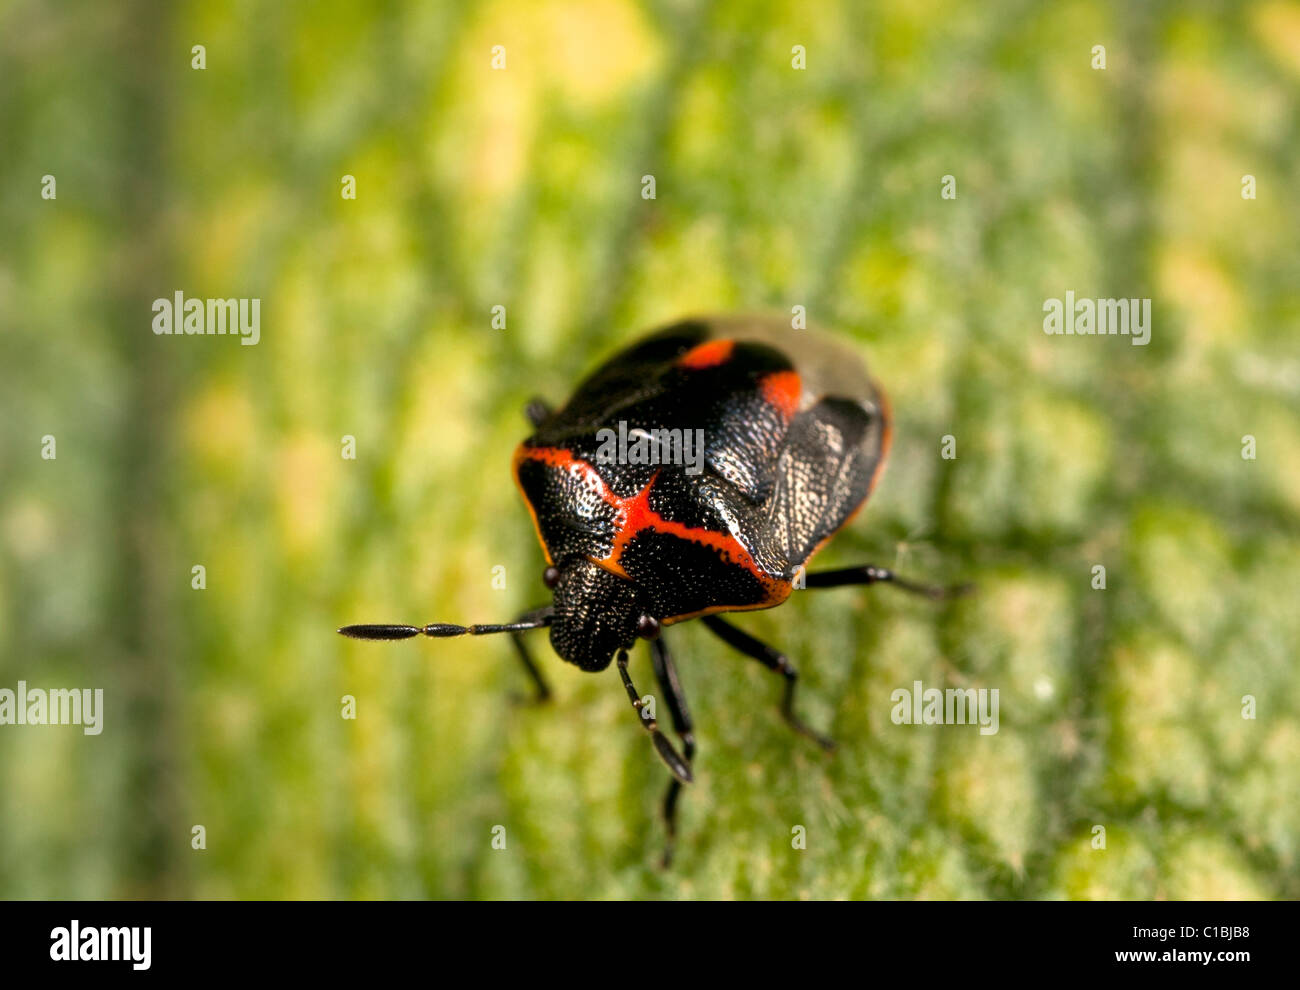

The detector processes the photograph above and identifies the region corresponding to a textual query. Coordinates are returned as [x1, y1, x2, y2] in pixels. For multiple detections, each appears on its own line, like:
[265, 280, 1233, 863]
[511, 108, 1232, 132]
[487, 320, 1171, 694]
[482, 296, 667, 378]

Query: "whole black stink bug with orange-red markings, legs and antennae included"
[338, 317, 967, 863]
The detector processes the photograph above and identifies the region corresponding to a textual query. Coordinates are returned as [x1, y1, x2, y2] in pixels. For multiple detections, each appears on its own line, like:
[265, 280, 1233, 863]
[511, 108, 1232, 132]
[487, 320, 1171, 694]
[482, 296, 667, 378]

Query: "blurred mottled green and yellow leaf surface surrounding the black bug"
[0, 0, 1300, 898]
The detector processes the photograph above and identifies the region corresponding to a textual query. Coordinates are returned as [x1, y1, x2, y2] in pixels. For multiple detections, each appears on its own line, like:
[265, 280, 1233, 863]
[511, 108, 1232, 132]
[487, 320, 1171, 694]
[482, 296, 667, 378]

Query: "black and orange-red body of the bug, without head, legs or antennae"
[514, 317, 889, 624]
